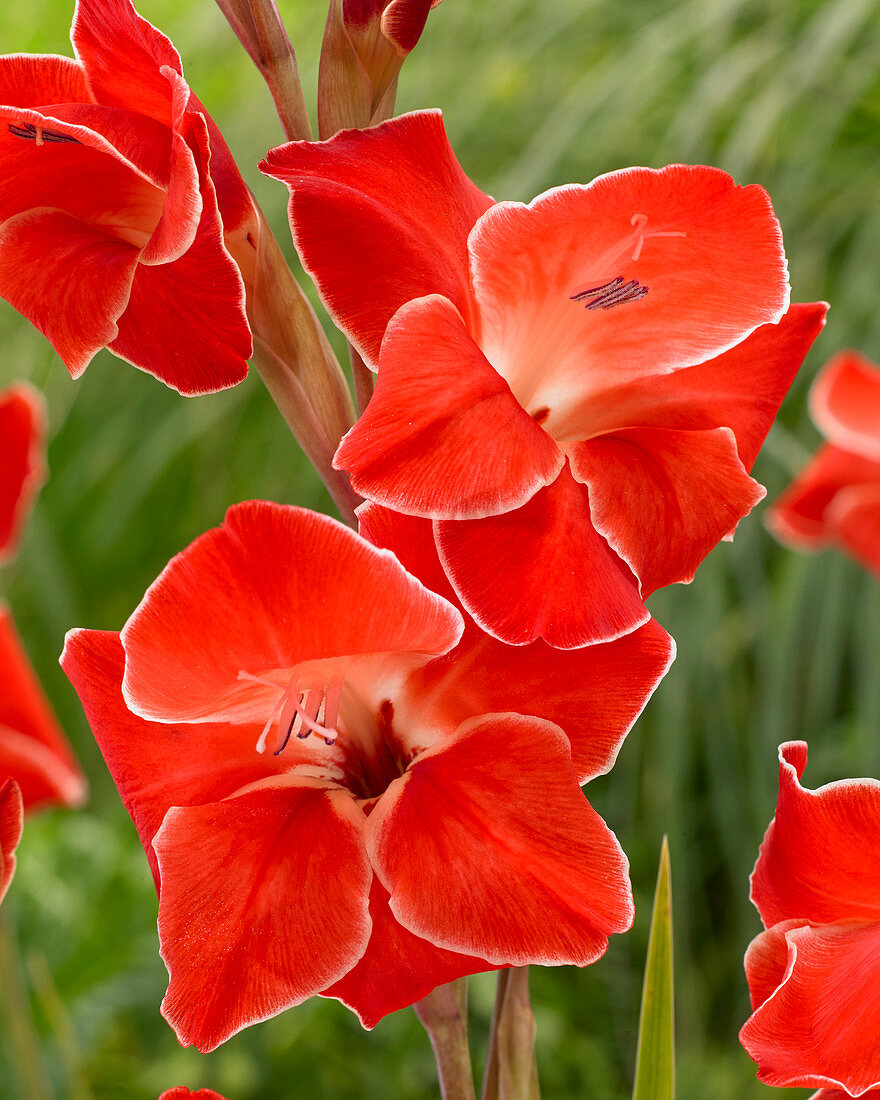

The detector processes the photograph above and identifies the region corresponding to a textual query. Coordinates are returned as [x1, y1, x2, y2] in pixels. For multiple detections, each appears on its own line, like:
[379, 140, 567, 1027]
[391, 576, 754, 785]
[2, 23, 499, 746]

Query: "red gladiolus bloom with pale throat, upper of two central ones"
[261, 112, 825, 648]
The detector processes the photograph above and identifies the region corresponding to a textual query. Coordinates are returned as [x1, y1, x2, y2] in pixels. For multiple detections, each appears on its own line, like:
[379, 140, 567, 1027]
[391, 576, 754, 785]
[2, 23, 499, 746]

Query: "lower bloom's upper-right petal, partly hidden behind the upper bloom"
[358, 504, 675, 783]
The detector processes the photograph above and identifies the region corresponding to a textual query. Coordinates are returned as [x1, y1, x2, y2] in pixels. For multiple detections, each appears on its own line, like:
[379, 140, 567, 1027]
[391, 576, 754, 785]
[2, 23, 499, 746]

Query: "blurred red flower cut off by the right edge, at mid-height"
[767, 351, 880, 576]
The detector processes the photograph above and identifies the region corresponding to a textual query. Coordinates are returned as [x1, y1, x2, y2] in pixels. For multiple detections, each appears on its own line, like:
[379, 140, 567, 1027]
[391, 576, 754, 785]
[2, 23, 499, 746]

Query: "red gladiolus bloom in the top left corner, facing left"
[0, 0, 255, 394]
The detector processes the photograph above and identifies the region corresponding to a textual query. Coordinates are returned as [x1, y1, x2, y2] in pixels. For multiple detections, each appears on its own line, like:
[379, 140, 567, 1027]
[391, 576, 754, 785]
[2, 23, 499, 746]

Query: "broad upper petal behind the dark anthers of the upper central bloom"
[470, 165, 789, 410]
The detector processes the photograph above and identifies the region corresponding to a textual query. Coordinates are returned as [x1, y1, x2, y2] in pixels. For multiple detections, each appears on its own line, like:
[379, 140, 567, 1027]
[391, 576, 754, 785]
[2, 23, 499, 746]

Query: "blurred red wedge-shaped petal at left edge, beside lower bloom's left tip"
[0, 606, 86, 810]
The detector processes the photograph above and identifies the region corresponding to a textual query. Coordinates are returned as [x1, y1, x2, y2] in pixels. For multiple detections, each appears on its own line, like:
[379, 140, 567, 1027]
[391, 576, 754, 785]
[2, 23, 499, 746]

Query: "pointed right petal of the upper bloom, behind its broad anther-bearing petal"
[554, 301, 827, 470]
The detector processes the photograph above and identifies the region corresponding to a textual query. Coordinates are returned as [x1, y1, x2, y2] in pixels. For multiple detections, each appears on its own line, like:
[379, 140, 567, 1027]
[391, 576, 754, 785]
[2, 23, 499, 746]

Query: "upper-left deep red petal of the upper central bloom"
[260, 111, 492, 364]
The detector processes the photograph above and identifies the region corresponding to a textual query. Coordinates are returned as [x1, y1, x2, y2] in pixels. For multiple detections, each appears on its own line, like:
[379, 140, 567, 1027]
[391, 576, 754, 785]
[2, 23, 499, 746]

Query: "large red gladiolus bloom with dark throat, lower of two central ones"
[62, 502, 671, 1051]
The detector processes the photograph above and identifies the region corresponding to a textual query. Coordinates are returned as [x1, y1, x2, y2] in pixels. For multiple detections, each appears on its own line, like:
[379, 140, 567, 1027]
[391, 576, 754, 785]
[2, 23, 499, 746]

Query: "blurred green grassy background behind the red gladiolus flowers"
[0, 0, 880, 1100]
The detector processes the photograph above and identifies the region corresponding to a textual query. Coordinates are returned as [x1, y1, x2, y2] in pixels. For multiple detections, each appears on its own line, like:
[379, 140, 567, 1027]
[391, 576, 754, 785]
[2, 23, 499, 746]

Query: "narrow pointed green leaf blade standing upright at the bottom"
[633, 837, 675, 1100]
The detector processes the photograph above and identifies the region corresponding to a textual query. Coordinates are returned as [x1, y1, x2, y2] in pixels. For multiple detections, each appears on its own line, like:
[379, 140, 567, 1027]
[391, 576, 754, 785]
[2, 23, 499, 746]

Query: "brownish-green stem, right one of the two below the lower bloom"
[481, 966, 541, 1100]
